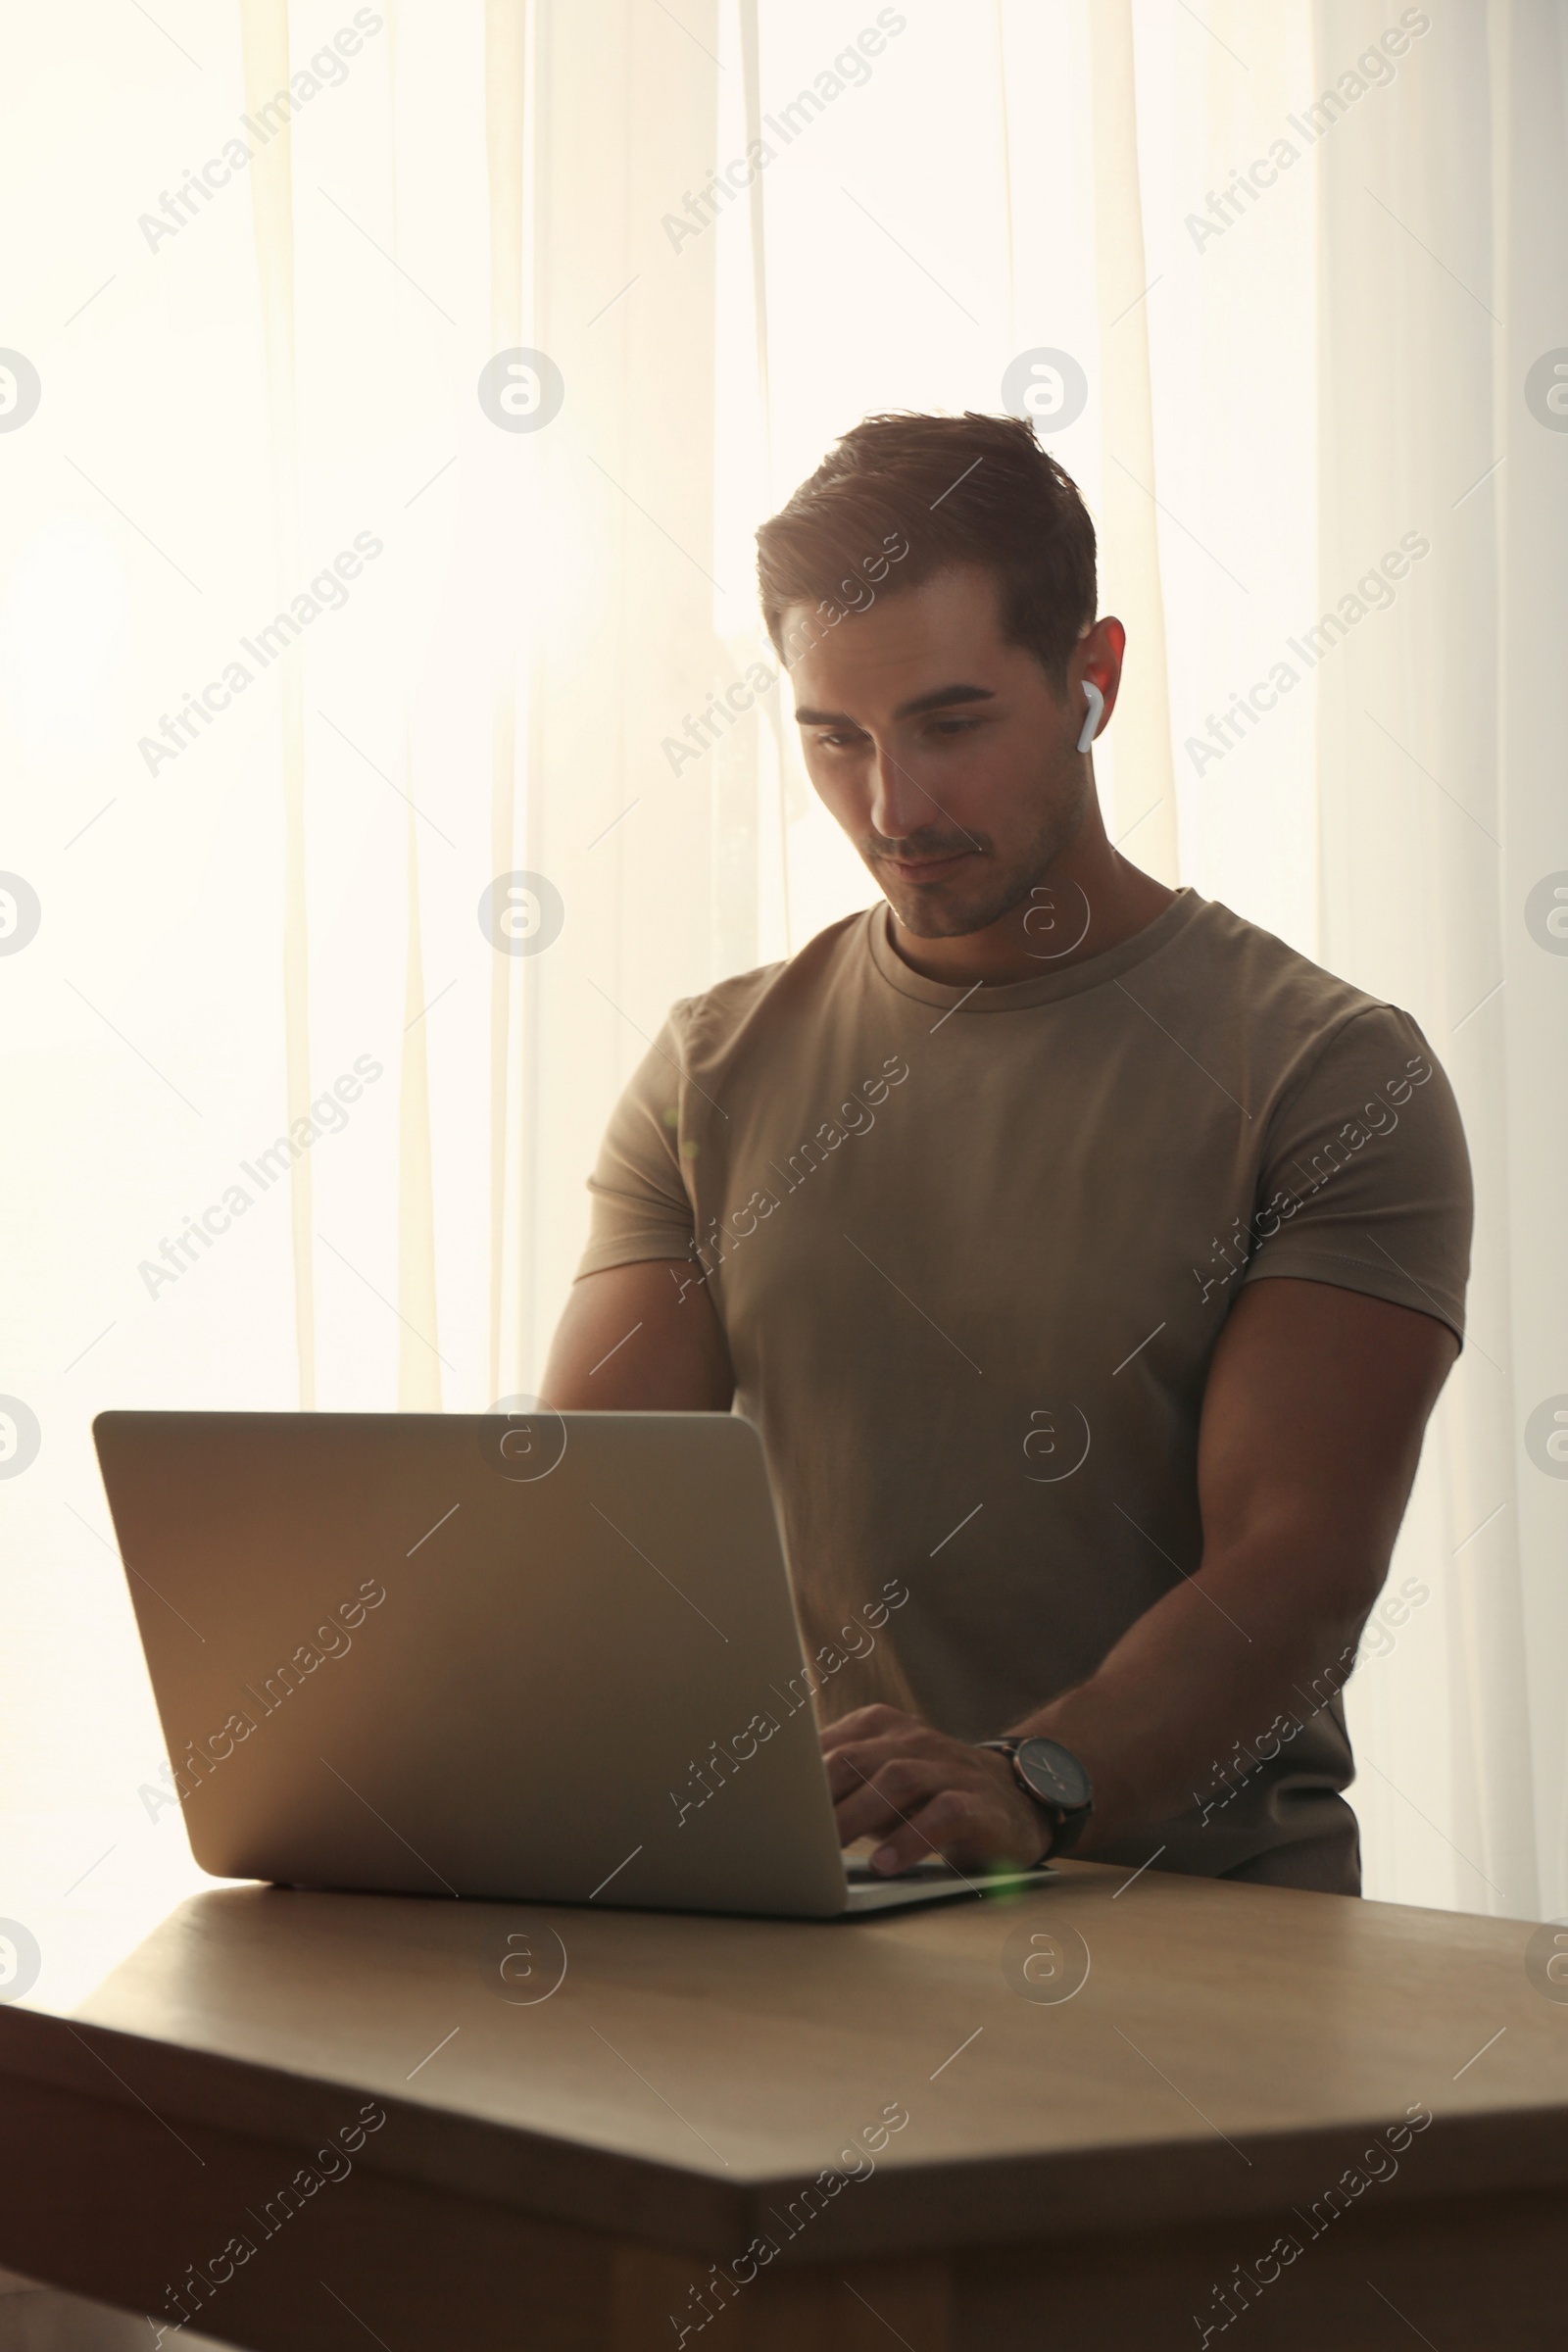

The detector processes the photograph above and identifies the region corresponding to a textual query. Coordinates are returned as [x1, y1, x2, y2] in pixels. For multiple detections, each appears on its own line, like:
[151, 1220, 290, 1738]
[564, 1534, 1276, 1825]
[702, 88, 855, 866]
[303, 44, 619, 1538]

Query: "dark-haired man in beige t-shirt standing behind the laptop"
[546, 416, 1469, 1893]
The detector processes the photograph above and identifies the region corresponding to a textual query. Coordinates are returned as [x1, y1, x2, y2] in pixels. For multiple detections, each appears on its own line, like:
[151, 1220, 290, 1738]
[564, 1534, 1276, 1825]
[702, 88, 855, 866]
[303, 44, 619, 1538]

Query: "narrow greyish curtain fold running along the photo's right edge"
[1494, 0, 1568, 1917]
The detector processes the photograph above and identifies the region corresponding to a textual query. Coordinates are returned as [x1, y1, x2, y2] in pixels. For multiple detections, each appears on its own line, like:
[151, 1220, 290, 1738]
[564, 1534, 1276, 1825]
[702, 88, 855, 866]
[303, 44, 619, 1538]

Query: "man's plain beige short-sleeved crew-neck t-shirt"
[578, 889, 1472, 1891]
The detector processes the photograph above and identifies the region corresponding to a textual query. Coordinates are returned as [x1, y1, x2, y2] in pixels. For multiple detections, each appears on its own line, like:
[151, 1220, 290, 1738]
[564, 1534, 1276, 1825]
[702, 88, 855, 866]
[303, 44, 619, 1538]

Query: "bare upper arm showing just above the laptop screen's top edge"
[543, 1258, 736, 1413]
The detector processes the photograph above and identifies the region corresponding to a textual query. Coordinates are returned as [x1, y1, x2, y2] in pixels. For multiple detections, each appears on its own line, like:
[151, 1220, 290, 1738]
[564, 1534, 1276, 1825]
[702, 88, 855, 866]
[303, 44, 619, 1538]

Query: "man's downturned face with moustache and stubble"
[783, 564, 1116, 939]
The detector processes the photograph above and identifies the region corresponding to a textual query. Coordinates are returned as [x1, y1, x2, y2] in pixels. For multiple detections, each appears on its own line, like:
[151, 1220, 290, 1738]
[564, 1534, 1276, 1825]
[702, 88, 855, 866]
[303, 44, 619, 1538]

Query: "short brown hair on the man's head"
[757, 410, 1096, 689]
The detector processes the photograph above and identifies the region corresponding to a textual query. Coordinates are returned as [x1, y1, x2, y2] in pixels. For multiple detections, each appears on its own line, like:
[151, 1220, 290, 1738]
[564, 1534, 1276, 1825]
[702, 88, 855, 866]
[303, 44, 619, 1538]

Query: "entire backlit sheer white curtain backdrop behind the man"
[0, 0, 1568, 1983]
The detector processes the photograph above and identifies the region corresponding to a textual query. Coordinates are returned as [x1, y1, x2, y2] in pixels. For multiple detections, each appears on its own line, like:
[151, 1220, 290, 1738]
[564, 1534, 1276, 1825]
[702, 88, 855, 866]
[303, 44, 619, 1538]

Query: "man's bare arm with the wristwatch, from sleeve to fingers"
[825, 1277, 1457, 1870]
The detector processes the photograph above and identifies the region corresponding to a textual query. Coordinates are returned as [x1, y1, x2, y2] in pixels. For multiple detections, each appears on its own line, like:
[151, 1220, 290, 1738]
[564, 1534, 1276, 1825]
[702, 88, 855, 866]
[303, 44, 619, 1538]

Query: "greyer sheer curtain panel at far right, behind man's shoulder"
[1316, 0, 1568, 1917]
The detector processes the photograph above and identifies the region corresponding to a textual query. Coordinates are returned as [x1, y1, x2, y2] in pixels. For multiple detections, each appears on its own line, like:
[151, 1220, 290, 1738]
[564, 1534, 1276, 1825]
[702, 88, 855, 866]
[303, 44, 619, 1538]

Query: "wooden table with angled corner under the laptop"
[0, 1865, 1568, 2352]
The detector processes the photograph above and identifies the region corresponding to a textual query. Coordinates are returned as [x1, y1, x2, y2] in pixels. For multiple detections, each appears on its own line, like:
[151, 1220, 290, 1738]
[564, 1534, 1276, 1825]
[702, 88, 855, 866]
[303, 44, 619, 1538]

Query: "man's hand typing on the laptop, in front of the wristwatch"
[823, 1707, 1051, 1877]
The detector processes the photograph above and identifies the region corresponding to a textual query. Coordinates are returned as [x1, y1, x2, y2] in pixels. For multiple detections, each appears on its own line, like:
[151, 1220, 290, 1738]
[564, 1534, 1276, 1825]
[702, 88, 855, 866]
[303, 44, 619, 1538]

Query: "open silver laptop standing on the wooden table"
[94, 1406, 1049, 1919]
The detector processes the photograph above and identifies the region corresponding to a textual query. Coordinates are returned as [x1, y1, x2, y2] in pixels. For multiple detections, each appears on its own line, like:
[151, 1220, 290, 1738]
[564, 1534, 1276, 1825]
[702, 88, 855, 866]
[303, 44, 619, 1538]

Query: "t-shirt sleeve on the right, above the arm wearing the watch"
[1246, 1004, 1474, 1341]
